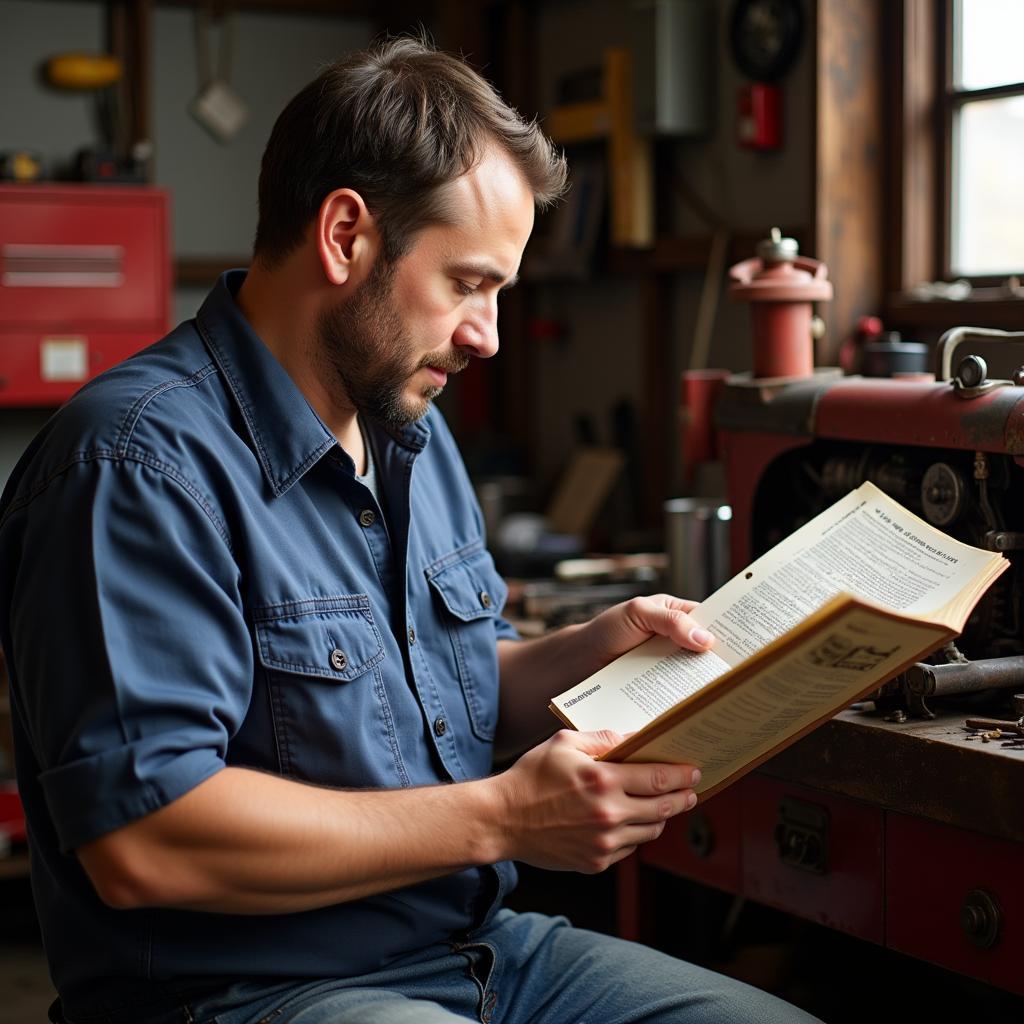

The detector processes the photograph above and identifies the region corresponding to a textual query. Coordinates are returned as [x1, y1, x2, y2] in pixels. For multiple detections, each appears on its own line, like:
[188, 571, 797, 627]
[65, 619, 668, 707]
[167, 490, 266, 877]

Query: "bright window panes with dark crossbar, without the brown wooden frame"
[943, 0, 1024, 279]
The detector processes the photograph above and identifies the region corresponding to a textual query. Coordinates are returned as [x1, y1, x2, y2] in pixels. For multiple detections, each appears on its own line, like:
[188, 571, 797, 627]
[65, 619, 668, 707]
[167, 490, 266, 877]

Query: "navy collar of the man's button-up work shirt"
[196, 270, 430, 496]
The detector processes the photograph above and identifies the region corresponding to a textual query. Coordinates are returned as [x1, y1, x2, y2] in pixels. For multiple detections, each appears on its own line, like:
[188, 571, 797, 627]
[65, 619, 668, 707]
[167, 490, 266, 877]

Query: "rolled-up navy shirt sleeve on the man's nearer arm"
[5, 454, 254, 851]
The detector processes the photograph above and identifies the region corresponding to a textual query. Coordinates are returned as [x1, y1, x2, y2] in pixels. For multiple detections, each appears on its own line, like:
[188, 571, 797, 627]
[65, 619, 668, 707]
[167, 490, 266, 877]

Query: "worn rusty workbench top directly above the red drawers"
[758, 710, 1024, 843]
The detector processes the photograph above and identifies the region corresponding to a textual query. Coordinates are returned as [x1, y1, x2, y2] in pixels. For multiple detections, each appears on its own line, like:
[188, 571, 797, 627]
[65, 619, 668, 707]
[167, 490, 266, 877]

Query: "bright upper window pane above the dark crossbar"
[953, 0, 1024, 89]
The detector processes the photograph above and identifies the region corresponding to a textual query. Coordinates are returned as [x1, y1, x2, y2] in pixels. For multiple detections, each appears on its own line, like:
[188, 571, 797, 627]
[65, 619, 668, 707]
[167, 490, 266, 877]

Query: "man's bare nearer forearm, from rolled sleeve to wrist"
[79, 768, 503, 913]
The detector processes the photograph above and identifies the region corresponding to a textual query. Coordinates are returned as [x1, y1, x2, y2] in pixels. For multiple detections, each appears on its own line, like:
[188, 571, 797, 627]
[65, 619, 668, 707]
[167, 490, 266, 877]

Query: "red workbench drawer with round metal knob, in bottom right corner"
[886, 814, 1024, 993]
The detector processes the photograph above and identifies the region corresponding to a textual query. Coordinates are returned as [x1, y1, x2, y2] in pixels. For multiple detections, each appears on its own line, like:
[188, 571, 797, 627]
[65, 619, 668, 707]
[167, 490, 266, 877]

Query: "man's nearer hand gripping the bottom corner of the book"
[489, 730, 700, 873]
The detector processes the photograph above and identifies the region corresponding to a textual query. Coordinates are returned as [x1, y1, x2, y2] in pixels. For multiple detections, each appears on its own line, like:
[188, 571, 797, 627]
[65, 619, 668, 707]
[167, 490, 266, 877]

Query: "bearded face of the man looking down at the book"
[315, 152, 534, 426]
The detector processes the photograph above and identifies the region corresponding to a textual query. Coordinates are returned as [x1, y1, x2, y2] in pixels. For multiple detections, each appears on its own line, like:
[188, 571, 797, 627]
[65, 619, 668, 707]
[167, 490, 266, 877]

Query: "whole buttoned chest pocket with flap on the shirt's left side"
[254, 594, 402, 786]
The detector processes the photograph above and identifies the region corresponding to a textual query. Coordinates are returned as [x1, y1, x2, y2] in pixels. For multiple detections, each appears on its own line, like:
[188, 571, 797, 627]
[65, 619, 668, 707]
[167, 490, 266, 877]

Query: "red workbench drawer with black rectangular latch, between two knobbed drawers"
[734, 774, 885, 943]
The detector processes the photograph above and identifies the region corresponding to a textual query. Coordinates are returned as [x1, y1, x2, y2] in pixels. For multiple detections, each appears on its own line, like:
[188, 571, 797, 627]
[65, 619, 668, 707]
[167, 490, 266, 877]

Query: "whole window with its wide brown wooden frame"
[884, 0, 1024, 327]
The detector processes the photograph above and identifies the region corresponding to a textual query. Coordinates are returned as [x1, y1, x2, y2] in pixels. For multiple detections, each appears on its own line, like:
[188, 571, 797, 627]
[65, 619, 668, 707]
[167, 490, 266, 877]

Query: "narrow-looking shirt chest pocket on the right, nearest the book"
[425, 542, 508, 741]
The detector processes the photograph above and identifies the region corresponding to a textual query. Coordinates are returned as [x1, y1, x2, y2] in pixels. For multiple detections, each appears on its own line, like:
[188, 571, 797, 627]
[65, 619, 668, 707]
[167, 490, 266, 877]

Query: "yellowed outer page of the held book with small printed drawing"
[606, 605, 949, 794]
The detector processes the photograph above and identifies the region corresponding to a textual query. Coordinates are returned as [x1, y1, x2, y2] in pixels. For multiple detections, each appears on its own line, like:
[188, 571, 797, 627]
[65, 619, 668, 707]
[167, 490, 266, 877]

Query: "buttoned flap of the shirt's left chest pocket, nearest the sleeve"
[255, 594, 384, 682]
